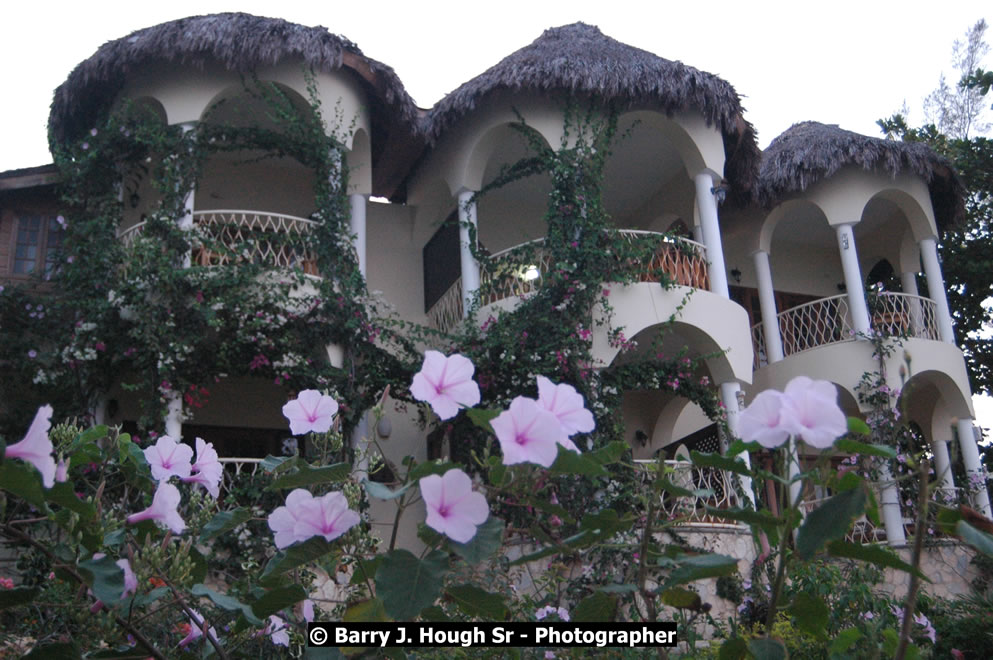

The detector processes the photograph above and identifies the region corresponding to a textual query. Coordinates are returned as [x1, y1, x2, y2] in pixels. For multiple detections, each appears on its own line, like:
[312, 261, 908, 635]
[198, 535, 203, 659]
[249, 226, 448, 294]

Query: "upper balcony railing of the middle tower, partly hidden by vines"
[428, 229, 710, 332]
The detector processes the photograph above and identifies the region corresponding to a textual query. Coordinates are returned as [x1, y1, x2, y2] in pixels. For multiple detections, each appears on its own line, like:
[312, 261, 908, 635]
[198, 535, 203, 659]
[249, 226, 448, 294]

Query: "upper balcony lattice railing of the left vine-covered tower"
[117, 210, 318, 275]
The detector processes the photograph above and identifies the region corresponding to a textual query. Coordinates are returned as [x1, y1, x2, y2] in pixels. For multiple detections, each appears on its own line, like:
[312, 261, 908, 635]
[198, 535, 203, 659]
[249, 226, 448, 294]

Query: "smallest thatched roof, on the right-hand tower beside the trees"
[758, 121, 965, 226]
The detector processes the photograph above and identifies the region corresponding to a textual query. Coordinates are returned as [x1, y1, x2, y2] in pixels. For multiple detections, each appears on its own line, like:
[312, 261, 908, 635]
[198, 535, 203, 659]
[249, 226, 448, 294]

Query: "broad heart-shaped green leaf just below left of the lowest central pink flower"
[376, 550, 448, 621]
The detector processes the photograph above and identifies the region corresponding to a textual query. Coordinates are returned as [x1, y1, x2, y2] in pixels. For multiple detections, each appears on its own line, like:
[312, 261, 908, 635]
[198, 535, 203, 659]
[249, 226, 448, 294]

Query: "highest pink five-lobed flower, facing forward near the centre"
[410, 351, 479, 419]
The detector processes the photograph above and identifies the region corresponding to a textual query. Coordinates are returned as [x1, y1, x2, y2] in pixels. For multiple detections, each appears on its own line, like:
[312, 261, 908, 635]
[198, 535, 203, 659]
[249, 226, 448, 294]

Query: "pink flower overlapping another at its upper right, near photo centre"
[490, 396, 563, 467]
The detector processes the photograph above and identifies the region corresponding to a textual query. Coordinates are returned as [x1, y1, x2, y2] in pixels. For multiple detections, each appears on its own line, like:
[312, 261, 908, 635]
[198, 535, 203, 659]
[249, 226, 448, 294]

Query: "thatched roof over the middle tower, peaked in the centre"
[424, 23, 759, 195]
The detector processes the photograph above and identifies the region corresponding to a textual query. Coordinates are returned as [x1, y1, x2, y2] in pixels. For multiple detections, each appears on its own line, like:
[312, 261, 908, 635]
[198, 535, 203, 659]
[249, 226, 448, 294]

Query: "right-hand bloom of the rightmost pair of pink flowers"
[783, 376, 848, 449]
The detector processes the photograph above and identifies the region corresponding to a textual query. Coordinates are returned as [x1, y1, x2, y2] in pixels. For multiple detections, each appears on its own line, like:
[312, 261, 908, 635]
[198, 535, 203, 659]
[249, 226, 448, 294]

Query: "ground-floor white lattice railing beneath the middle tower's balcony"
[635, 460, 738, 525]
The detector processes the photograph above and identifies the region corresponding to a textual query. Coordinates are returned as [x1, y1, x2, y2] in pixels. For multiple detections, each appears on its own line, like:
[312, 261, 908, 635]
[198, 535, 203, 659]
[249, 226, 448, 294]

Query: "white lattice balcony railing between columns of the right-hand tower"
[752, 292, 939, 369]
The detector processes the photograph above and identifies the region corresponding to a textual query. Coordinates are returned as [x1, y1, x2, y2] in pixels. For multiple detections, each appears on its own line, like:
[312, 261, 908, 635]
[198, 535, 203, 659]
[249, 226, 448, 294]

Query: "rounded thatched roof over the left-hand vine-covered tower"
[48, 13, 418, 196]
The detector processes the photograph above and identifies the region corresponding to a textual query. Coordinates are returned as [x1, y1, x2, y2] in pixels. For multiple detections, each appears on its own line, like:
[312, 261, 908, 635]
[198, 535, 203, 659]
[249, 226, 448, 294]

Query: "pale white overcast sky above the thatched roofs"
[0, 0, 993, 426]
